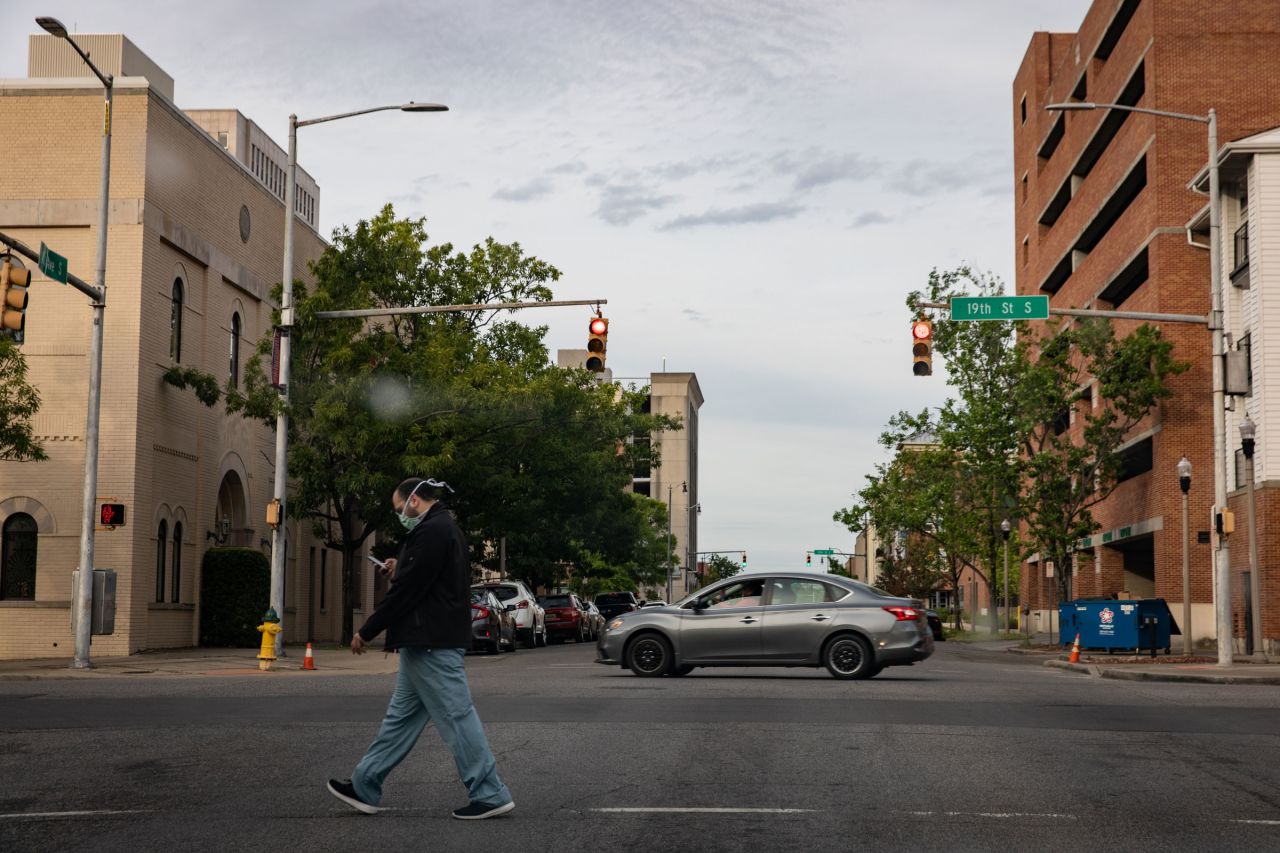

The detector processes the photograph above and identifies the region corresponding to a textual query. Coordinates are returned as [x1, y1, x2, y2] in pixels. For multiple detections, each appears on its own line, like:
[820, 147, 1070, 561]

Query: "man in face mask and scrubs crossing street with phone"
[329, 478, 516, 821]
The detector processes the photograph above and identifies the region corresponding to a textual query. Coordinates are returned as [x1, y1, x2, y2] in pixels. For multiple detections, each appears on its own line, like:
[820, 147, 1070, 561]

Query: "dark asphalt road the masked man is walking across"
[0, 643, 1280, 853]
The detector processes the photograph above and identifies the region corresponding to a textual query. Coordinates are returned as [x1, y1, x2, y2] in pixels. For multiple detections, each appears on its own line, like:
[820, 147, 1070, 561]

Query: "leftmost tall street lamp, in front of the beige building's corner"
[36, 17, 115, 670]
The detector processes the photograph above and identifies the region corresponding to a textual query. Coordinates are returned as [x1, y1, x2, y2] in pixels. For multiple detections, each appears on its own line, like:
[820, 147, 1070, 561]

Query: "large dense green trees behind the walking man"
[227, 206, 680, 638]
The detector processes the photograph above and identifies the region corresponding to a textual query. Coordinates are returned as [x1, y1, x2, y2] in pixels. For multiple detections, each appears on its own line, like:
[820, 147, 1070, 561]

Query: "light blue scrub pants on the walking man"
[351, 648, 511, 806]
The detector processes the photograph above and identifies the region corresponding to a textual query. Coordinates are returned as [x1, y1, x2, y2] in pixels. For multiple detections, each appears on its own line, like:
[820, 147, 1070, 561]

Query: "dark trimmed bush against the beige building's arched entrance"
[200, 548, 271, 648]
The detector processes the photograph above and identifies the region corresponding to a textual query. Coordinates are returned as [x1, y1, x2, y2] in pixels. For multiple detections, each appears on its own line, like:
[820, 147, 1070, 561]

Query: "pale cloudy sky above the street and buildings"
[0, 0, 1088, 569]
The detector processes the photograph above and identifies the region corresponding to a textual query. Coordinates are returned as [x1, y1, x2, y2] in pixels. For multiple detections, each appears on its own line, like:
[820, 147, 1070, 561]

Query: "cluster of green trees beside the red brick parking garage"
[835, 262, 1187, 607]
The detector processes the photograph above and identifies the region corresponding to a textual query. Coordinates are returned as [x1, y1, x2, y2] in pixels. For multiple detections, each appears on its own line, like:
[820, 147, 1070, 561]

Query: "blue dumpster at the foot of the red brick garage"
[1059, 598, 1181, 654]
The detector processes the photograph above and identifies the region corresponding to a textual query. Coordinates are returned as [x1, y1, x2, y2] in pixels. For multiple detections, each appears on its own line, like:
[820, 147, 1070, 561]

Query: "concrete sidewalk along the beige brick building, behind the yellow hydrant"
[0, 646, 399, 681]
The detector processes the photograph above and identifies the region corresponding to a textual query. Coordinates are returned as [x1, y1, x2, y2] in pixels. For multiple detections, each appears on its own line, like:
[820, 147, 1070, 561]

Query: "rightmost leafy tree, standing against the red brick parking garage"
[1016, 320, 1188, 601]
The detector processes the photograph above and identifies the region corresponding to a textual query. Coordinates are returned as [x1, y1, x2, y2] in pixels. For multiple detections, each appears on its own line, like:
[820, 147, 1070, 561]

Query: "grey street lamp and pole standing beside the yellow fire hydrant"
[271, 101, 449, 648]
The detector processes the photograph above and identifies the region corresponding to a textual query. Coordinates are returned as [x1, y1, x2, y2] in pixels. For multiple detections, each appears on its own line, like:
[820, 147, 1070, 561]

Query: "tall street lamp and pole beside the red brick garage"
[1044, 101, 1233, 666]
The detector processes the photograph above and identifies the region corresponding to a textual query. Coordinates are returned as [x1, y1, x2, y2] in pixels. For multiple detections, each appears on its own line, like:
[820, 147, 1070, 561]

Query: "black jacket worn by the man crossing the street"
[360, 503, 471, 651]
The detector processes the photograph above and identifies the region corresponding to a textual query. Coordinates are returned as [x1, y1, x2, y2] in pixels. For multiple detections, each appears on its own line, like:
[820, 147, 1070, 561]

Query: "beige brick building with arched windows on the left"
[0, 35, 358, 658]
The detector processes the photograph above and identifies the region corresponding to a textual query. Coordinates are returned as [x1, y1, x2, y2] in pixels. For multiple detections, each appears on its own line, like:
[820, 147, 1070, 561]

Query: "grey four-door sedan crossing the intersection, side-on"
[596, 571, 933, 679]
